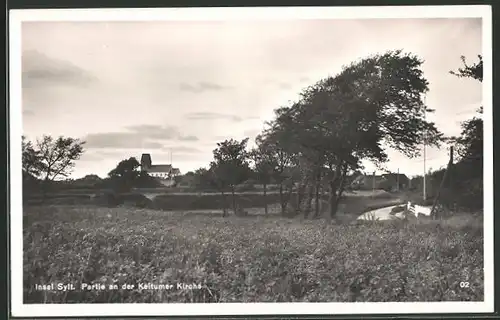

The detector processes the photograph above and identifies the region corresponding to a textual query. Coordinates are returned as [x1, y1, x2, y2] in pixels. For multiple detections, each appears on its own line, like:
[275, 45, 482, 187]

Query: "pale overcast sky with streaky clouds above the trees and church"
[22, 18, 482, 177]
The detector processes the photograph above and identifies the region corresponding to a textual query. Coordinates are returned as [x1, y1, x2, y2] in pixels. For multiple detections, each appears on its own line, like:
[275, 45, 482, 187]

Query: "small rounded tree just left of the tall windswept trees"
[209, 138, 250, 215]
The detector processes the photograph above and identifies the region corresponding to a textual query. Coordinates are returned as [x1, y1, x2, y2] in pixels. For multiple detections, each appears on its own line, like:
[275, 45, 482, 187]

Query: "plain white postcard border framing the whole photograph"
[9, 5, 494, 317]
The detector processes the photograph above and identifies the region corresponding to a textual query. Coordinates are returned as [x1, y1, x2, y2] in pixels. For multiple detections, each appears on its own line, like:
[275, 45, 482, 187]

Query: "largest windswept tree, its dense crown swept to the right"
[264, 50, 442, 217]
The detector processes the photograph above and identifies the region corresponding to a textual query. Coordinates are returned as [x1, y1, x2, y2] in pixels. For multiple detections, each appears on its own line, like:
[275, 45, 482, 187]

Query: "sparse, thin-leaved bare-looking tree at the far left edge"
[34, 135, 85, 193]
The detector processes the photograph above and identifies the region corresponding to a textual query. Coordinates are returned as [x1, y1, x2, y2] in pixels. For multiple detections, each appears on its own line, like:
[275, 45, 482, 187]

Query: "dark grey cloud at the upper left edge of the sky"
[22, 50, 97, 88]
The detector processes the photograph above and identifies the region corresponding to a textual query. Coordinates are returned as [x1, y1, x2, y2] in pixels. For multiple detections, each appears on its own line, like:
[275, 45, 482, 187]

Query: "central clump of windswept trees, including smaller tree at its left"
[192, 51, 444, 217]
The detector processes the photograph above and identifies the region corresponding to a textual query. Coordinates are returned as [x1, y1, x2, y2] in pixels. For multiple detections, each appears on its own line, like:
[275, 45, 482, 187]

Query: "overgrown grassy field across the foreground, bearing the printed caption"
[23, 206, 483, 303]
